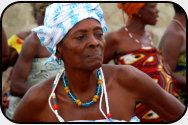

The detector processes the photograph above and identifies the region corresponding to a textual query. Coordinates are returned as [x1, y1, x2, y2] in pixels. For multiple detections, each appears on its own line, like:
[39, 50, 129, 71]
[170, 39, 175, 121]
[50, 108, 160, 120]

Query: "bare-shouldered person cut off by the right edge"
[159, 4, 187, 105]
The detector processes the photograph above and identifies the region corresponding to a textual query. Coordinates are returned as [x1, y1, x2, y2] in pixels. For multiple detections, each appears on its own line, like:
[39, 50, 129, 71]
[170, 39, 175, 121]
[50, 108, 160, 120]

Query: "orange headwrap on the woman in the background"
[117, 3, 145, 22]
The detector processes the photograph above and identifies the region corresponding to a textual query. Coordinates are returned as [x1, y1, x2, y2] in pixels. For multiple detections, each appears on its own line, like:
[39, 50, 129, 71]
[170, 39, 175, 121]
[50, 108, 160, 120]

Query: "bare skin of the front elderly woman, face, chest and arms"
[13, 19, 185, 122]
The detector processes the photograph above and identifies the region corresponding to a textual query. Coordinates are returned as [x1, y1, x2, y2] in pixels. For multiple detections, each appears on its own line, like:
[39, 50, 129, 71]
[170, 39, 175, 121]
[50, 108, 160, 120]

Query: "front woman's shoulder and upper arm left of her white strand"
[12, 77, 55, 122]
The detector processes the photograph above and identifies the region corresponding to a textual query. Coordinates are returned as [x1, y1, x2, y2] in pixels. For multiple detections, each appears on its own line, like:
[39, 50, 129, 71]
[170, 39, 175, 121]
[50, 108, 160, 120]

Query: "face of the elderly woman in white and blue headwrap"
[57, 19, 105, 69]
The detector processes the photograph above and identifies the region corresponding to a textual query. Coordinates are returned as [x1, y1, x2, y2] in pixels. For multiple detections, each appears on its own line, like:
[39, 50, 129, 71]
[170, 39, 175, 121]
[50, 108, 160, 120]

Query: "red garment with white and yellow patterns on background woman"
[114, 47, 177, 122]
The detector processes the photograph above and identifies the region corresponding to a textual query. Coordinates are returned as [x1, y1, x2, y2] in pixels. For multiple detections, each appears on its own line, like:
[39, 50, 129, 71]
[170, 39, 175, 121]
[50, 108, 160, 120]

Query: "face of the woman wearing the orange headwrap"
[139, 3, 159, 25]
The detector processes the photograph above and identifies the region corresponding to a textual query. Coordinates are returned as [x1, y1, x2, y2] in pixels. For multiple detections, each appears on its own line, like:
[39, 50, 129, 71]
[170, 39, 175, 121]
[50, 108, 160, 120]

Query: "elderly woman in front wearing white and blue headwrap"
[13, 3, 185, 122]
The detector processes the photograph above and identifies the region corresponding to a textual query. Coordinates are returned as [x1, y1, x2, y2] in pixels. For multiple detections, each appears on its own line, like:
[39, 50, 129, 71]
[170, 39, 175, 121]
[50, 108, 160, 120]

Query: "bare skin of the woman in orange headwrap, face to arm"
[104, 3, 158, 63]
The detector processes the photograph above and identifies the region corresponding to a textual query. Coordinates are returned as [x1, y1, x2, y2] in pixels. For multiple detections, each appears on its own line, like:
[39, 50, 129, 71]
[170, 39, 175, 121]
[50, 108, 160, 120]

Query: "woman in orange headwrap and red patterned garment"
[104, 3, 182, 122]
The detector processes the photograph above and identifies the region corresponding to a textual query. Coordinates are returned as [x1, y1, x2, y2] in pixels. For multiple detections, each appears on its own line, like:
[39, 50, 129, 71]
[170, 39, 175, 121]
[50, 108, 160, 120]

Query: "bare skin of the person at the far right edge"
[159, 13, 186, 91]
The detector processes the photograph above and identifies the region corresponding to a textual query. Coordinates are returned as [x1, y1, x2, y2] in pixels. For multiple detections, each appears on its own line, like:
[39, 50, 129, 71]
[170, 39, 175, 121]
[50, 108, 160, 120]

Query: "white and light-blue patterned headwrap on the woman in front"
[32, 3, 107, 64]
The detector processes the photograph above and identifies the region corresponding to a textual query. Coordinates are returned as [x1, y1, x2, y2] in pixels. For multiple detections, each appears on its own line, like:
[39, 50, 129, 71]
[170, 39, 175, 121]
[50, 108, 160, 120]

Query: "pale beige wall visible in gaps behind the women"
[2, 3, 174, 86]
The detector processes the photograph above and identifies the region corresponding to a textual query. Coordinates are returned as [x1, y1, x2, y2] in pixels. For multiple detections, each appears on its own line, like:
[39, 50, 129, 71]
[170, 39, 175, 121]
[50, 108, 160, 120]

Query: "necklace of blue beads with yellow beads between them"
[63, 69, 102, 107]
